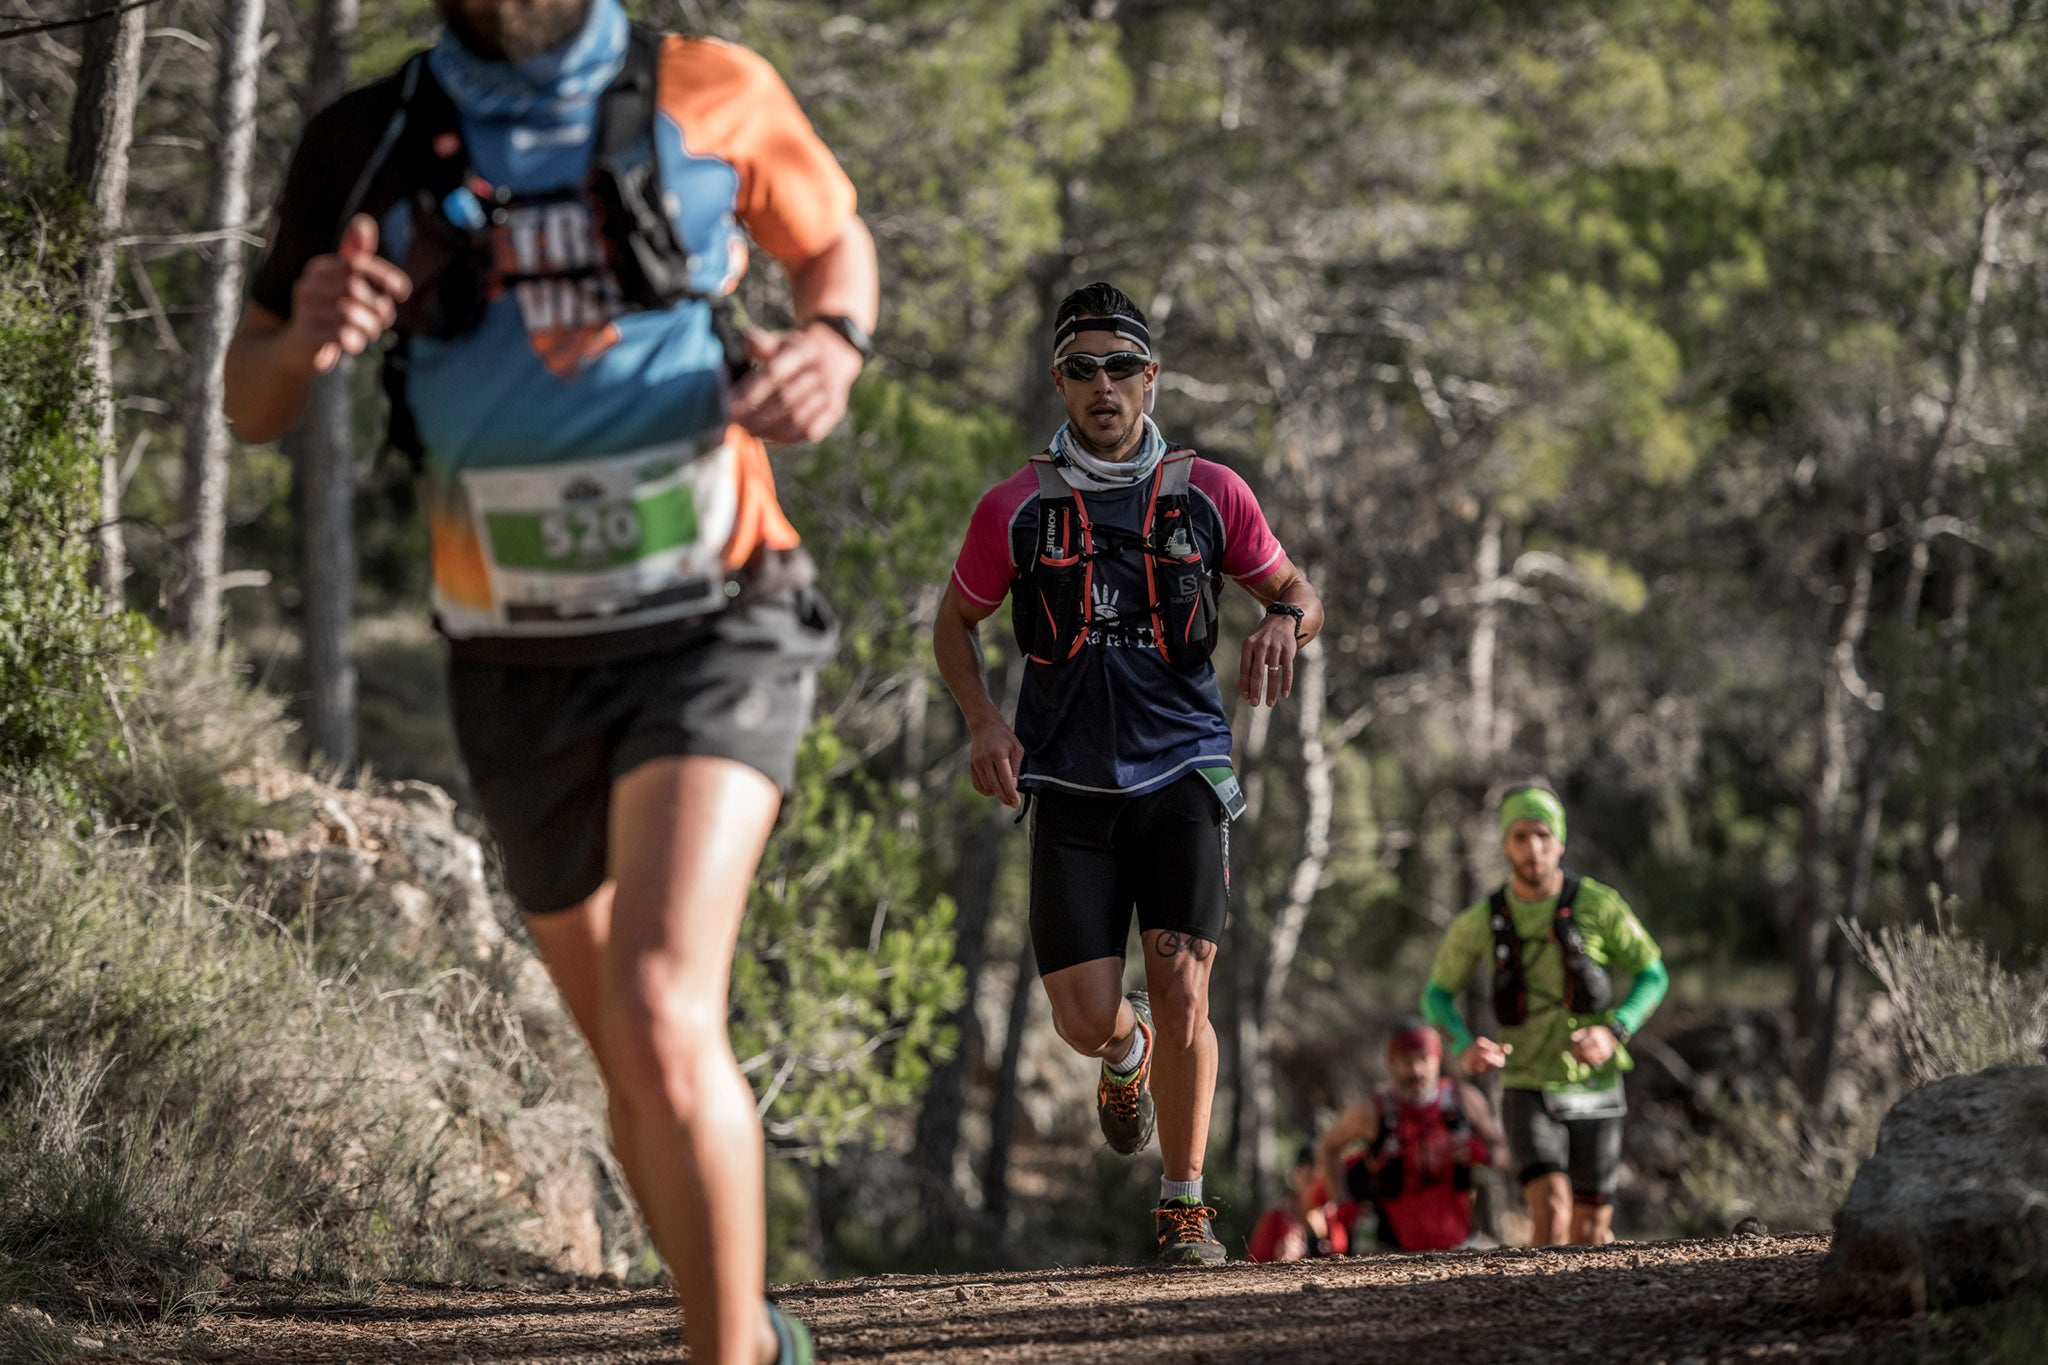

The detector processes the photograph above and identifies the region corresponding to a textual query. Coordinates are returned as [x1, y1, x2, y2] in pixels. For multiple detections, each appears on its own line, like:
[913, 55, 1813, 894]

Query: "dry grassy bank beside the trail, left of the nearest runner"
[0, 657, 622, 1359]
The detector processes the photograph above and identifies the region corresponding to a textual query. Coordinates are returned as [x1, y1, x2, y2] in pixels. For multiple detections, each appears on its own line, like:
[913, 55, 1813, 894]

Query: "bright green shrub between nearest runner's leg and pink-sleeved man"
[731, 720, 965, 1160]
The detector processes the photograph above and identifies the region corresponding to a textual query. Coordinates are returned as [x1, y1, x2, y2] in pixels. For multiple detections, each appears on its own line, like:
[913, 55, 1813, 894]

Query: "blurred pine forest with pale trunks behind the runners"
[0, 0, 2048, 1308]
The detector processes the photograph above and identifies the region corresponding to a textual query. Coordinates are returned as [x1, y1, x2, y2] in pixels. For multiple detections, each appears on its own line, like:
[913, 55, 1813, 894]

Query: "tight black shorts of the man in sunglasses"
[1030, 772, 1231, 976]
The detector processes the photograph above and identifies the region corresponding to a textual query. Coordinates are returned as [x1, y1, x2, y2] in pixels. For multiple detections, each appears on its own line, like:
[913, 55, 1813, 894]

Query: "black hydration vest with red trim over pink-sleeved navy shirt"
[1010, 446, 1223, 669]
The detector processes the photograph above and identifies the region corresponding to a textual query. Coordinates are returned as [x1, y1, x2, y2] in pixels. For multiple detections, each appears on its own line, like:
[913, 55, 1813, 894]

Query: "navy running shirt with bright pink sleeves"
[952, 458, 1284, 796]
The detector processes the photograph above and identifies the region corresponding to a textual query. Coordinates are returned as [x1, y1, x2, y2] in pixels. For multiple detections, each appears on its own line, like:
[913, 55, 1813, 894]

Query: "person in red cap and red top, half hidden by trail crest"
[1315, 1019, 1505, 1250]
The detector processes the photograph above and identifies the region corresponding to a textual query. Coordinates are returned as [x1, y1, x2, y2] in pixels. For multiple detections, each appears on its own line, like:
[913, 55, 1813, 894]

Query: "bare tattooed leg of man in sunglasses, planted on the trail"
[1143, 929, 1217, 1181]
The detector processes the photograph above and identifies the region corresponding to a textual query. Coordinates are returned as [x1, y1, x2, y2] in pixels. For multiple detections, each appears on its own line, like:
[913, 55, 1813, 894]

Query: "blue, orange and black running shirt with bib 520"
[250, 0, 854, 663]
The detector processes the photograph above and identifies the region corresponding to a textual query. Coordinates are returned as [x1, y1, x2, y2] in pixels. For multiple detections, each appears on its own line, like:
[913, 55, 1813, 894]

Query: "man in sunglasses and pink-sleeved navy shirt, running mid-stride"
[932, 284, 1323, 1265]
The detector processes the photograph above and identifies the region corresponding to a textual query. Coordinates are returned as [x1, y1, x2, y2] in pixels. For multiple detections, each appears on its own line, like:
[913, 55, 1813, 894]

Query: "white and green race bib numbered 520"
[428, 442, 739, 639]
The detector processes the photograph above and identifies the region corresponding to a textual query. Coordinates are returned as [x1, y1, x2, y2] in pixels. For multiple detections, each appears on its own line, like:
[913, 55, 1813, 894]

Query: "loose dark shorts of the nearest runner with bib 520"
[449, 587, 838, 915]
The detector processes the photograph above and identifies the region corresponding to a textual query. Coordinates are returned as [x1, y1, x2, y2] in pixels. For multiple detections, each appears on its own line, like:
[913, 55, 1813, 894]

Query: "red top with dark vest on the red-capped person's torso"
[1368, 1076, 1487, 1250]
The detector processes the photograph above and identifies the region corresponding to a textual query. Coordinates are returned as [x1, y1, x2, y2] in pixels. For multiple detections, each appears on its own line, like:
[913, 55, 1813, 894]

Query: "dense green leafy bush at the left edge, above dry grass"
[0, 143, 143, 786]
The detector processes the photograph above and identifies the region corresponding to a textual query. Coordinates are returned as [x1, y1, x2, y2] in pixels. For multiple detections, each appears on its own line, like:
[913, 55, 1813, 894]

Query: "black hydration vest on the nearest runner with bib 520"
[336, 25, 748, 460]
